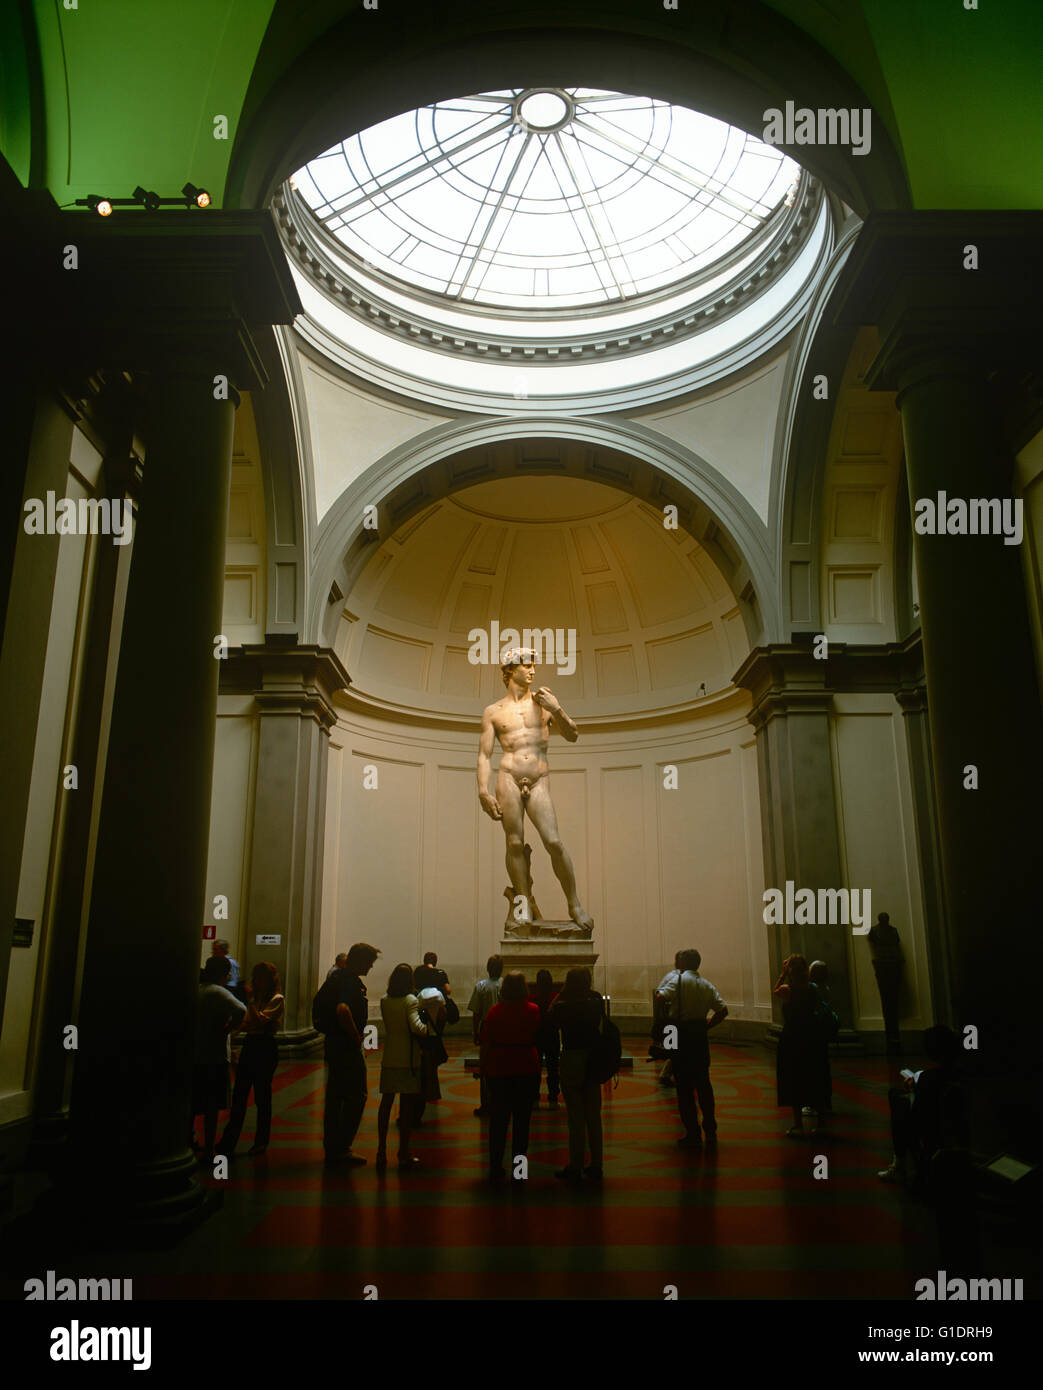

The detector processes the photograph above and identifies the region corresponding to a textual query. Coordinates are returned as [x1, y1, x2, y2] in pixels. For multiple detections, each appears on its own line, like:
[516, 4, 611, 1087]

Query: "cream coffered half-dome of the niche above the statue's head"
[337, 477, 748, 723]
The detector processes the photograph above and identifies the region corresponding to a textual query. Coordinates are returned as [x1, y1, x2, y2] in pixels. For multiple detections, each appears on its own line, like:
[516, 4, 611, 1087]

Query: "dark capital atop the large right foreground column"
[832, 211, 1043, 414]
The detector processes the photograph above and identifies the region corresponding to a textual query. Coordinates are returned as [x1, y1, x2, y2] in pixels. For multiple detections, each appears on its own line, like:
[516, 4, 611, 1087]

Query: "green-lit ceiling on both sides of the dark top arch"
[0, 0, 1043, 209]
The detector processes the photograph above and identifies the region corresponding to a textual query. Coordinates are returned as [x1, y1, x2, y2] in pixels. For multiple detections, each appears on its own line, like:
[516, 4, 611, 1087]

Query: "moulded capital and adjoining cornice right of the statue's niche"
[731, 632, 926, 731]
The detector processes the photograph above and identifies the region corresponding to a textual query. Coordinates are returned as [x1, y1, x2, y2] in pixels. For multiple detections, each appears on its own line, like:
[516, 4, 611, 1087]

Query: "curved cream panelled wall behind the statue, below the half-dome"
[323, 706, 770, 1020]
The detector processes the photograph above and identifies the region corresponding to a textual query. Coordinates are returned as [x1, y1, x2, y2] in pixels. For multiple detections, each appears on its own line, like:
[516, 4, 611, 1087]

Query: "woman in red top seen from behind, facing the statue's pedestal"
[481, 970, 540, 1183]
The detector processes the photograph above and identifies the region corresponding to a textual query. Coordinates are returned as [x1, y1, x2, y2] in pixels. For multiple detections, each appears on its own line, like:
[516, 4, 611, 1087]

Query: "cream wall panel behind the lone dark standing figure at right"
[832, 695, 935, 1031]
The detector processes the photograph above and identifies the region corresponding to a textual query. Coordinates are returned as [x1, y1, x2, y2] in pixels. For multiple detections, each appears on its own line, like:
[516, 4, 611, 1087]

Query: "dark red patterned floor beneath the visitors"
[134, 1040, 933, 1300]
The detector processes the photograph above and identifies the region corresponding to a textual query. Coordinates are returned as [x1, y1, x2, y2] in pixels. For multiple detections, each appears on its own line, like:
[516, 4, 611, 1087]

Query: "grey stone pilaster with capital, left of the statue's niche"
[221, 637, 349, 1056]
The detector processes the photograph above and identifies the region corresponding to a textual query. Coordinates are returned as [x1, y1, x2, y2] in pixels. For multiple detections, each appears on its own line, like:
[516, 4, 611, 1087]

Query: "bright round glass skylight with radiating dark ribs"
[293, 88, 800, 310]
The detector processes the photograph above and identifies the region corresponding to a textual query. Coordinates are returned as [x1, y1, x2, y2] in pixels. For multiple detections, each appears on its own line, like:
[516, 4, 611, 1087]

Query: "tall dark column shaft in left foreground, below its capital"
[63, 375, 235, 1227]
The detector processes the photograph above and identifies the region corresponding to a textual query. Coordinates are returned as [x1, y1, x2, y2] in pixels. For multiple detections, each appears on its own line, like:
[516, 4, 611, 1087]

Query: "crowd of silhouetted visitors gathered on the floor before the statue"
[192, 941, 961, 1183]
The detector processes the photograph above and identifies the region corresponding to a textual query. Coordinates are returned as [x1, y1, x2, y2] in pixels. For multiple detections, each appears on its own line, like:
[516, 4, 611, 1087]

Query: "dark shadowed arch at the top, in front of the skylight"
[224, 0, 909, 215]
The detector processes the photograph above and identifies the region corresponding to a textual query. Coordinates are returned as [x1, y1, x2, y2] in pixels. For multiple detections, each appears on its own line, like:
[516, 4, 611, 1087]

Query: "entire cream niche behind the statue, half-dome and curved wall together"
[320, 467, 770, 1029]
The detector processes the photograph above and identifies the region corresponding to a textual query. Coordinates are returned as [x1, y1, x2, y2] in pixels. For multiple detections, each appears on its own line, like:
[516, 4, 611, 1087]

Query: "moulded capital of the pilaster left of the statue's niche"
[220, 635, 352, 733]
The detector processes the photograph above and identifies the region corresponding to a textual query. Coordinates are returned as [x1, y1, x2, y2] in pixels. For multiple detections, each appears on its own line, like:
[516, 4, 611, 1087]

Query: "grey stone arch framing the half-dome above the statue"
[307, 416, 777, 646]
